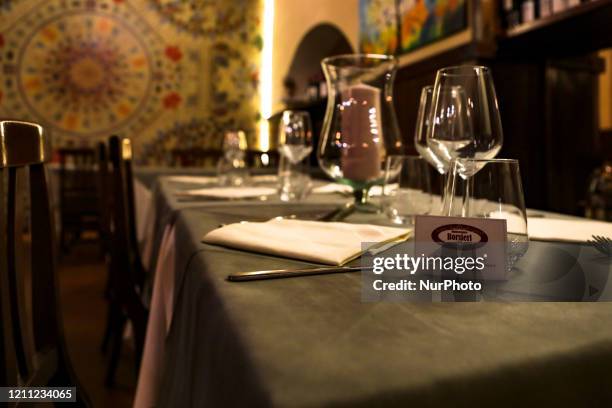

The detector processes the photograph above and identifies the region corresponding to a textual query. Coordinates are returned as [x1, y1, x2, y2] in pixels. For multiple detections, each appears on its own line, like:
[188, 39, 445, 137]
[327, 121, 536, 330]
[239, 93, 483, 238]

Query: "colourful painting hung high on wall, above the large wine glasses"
[359, 0, 467, 54]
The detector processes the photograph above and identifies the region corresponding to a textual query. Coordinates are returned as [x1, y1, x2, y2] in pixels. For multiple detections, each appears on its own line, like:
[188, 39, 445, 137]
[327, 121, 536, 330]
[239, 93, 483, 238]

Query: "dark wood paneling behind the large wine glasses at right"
[394, 0, 612, 214]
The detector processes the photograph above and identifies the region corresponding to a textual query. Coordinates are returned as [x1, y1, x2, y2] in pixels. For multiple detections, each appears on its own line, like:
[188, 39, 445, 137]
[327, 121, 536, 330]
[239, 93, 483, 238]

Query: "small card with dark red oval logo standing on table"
[415, 215, 507, 280]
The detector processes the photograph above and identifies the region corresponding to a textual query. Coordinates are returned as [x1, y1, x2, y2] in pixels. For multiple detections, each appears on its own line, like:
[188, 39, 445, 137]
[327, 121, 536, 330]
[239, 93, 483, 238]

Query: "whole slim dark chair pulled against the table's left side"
[106, 136, 148, 386]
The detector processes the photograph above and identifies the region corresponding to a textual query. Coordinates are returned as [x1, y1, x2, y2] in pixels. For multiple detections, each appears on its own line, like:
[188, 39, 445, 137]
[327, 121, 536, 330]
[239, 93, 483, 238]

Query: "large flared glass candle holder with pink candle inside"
[317, 54, 402, 215]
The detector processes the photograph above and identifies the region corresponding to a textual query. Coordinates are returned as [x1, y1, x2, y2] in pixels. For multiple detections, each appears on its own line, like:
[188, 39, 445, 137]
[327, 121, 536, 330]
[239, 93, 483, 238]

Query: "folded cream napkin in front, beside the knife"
[203, 219, 412, 265]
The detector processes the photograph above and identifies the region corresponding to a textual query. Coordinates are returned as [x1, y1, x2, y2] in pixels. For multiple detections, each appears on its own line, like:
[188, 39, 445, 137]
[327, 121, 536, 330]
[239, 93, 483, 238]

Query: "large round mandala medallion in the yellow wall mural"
[0, 0, 182, 137]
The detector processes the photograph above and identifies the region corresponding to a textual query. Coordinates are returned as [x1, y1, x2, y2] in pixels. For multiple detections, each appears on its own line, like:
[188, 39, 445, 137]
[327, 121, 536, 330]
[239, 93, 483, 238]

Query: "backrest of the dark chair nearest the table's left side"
[109, 136, 147, 355]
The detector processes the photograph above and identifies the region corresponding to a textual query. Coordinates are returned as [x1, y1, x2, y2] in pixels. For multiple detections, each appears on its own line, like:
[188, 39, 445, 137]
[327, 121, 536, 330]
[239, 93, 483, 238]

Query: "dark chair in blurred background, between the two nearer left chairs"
[58, 148, 100, 252]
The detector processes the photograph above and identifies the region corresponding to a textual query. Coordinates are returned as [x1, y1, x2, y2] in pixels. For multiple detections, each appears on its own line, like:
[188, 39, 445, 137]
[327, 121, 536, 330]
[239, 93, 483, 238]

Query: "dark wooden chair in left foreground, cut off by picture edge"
[0, 121, 91, 406]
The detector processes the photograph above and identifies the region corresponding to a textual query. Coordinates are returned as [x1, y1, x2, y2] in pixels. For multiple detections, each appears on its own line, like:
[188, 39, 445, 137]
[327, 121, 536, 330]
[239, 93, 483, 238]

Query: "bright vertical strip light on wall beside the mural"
[259, 0, 275, 152]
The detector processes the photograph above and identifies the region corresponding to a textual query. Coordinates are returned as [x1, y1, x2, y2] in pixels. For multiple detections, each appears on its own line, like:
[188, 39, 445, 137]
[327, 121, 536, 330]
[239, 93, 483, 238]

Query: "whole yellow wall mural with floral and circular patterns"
[0, 0, 262, 163]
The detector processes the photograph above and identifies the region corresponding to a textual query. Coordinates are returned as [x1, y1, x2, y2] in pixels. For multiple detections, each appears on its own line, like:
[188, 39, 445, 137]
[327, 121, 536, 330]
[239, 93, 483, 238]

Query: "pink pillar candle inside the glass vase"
[340, 84, 383, 181]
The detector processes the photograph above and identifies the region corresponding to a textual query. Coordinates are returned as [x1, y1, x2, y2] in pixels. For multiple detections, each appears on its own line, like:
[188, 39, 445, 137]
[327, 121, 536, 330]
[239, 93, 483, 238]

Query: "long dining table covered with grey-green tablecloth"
[134, 168, 612, 407]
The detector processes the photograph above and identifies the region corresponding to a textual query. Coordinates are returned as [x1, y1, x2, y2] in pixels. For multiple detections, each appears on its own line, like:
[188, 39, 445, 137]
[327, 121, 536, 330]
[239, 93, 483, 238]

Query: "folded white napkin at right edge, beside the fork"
[527, 218, 612, 242]
